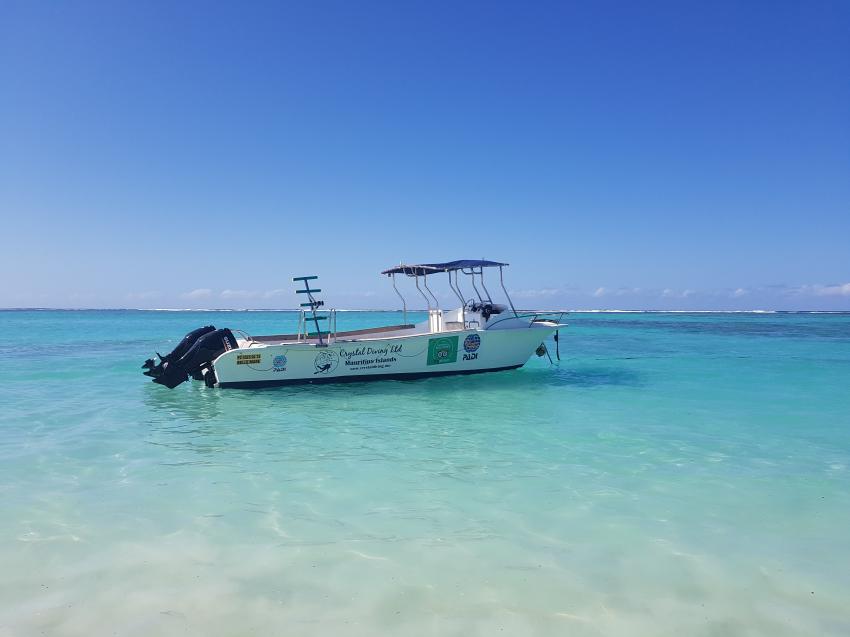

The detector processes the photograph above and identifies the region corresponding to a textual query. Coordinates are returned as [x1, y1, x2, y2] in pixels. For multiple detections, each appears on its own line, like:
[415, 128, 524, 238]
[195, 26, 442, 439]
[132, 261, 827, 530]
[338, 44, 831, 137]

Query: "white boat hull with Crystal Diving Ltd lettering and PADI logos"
[212, 325, 554, 388]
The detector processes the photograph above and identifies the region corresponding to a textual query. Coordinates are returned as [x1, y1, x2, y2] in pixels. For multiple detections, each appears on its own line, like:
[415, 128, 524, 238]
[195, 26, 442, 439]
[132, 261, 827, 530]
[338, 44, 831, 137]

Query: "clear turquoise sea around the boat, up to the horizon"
[0, 311, 850, 637]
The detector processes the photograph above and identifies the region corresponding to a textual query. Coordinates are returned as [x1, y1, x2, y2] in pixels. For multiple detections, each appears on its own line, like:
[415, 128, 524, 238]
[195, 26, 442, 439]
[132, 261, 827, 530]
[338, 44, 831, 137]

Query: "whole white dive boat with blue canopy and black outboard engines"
[142, 260, 564, 388]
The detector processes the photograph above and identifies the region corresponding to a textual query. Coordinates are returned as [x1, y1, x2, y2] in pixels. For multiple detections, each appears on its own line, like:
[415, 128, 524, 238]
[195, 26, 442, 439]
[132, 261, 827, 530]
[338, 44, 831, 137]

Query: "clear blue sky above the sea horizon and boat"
[0, 1, 850, 309]
